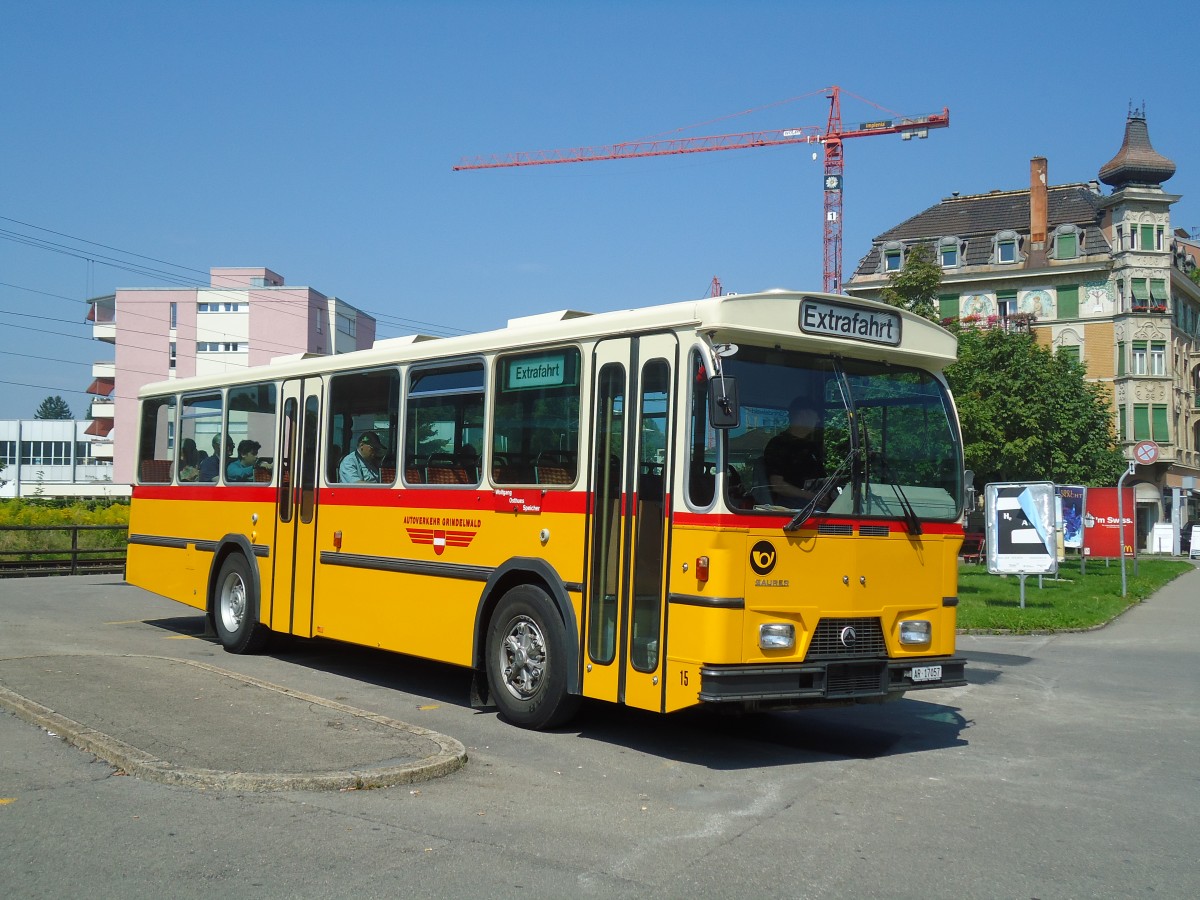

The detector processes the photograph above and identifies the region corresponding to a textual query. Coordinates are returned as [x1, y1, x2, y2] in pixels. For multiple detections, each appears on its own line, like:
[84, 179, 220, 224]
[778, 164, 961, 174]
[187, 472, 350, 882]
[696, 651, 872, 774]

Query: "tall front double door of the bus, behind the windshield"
[583, 335, 678, 709]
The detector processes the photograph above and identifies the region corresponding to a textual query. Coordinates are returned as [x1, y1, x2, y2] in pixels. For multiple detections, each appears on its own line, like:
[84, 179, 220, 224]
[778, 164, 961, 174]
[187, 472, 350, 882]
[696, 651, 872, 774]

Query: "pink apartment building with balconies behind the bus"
[88, 268, 376, 484]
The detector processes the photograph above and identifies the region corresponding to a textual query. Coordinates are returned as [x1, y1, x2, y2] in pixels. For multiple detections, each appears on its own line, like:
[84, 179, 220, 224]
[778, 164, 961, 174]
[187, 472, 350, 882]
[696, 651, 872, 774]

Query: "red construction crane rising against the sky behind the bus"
[454, 85, 950, 294]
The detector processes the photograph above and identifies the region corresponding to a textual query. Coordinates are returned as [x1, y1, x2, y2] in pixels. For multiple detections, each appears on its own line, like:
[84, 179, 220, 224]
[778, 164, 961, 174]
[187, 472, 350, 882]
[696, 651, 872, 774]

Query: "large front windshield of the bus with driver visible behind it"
[721, 347, 962, 532]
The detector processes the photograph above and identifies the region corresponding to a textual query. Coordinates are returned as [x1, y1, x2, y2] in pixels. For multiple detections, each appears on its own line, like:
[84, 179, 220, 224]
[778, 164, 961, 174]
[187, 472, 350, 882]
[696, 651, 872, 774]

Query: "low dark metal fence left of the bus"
[0, 526, 127, 578]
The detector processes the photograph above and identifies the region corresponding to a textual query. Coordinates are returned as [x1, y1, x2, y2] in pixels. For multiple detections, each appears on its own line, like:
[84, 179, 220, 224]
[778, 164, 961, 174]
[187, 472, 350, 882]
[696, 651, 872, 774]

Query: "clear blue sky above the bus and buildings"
[0, 0, 1200, 418]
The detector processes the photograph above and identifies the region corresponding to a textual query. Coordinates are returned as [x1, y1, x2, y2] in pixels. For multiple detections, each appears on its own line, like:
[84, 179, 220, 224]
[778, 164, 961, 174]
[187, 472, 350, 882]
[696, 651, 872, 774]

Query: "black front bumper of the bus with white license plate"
[700, 656, 967, 704]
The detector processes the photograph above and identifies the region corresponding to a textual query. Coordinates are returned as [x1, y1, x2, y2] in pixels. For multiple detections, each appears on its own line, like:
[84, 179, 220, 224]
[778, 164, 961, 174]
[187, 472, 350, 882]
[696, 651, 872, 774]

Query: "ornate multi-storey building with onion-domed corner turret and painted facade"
[846, 110, 1200, 551]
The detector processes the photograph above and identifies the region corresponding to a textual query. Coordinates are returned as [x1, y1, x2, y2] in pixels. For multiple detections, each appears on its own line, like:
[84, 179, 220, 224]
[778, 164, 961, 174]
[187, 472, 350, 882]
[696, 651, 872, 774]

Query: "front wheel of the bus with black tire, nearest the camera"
[486, 584, 580, 728]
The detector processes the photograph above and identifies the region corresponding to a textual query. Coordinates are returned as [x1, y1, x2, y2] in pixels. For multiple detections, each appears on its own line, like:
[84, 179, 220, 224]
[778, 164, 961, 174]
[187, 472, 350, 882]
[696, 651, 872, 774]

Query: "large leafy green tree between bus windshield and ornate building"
[946, 326, 1126, 486]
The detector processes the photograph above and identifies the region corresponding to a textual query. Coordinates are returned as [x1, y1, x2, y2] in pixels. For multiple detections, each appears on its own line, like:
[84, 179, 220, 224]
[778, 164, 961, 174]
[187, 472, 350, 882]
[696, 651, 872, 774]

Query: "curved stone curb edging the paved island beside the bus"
[0, 654, 467, 792]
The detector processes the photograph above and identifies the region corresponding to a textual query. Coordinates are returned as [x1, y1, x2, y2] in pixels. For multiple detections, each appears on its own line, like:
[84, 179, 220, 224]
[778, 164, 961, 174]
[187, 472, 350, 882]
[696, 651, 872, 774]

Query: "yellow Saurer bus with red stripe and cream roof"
[127, 290, 965, 728]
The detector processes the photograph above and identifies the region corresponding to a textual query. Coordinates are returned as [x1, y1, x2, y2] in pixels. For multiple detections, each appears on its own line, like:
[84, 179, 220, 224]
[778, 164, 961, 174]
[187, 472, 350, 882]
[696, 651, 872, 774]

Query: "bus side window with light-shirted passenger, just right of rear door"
[325, 368, 400, 485]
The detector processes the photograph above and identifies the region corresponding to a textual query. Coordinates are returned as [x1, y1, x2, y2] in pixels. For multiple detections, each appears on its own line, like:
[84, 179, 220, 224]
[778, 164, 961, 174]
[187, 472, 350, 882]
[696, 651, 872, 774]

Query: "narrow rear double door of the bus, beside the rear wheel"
[270, 378, 322, 637]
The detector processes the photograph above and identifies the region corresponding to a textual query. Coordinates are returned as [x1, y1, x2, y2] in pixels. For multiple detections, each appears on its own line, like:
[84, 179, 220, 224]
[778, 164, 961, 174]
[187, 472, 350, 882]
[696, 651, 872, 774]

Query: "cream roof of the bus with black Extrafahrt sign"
[140, 290, 958, 395]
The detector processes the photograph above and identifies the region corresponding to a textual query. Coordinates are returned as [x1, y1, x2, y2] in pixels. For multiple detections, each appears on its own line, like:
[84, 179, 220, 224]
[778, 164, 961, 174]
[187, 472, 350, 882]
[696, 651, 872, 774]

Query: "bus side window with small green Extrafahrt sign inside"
[491, 347, 580, 486]
